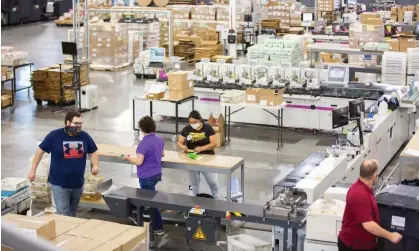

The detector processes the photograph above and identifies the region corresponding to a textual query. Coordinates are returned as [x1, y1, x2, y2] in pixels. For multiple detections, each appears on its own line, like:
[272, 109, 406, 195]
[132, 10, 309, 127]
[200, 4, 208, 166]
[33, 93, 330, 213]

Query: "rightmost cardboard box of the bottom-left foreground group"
[111, 226, 147, 251]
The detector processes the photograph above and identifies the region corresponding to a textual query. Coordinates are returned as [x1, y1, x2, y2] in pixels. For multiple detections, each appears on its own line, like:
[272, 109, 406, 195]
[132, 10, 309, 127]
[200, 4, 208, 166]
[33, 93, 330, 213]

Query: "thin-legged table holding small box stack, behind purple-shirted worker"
[132, 96, 198, 141]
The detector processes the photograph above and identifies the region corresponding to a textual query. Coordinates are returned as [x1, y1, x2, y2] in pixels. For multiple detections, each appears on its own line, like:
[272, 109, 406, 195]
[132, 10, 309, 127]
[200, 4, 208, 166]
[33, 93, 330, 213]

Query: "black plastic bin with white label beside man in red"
[376, 185, 419, 251]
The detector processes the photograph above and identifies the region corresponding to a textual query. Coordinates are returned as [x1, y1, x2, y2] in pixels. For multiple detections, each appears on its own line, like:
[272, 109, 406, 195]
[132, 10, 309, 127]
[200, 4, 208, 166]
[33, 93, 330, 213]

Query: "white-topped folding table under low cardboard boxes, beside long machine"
[220, 102, 287, 150]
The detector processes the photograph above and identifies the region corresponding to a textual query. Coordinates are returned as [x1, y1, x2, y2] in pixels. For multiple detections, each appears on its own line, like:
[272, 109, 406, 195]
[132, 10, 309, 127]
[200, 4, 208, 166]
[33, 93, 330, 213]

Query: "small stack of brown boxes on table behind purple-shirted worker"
[168, 71, 194, 100]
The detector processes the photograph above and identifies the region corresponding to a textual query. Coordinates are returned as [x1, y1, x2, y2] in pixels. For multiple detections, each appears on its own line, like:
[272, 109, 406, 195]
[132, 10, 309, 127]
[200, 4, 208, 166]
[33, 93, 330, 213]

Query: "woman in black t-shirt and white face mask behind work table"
[177, 111, 218, 199]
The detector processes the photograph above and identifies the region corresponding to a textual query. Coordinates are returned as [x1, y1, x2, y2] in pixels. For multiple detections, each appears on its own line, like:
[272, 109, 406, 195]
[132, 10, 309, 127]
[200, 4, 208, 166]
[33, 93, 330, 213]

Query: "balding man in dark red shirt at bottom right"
[338, 160, 402, 251]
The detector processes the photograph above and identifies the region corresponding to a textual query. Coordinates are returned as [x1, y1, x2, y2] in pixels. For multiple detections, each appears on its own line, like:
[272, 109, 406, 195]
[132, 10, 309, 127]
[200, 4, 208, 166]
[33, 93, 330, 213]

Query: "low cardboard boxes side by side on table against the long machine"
[246, 88, 285, 106]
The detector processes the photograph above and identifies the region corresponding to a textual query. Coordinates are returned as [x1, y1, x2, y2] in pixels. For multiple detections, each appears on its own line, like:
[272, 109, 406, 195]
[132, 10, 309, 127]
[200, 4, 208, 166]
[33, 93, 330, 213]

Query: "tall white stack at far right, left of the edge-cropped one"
[381, 51, 407, 85]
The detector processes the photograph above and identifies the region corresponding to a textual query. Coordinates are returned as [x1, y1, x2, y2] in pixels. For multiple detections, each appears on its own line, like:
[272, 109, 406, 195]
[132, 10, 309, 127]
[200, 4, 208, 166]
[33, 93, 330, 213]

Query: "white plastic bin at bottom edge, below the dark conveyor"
[227, 234, 272, 251]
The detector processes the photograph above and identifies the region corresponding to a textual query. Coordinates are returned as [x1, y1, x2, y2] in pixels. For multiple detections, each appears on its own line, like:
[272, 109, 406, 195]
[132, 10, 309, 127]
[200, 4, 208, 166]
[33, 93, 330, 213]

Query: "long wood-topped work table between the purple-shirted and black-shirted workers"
[97, 144, 244, 202]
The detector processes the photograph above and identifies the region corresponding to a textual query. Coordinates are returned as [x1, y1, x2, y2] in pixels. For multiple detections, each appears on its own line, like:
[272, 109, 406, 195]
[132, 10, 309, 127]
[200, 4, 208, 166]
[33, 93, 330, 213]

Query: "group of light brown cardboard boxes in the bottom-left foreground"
[2, 214, 148, 251]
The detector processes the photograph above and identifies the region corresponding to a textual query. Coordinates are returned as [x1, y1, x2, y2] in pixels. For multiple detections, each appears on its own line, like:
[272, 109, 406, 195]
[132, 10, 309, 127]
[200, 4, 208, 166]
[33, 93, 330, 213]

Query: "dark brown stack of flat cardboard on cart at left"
[31, 65, 88, 104]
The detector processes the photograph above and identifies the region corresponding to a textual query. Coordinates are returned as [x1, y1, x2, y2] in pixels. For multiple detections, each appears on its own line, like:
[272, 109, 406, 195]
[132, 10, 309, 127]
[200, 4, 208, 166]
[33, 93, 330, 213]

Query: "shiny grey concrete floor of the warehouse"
[1, 23, 413, 250]
